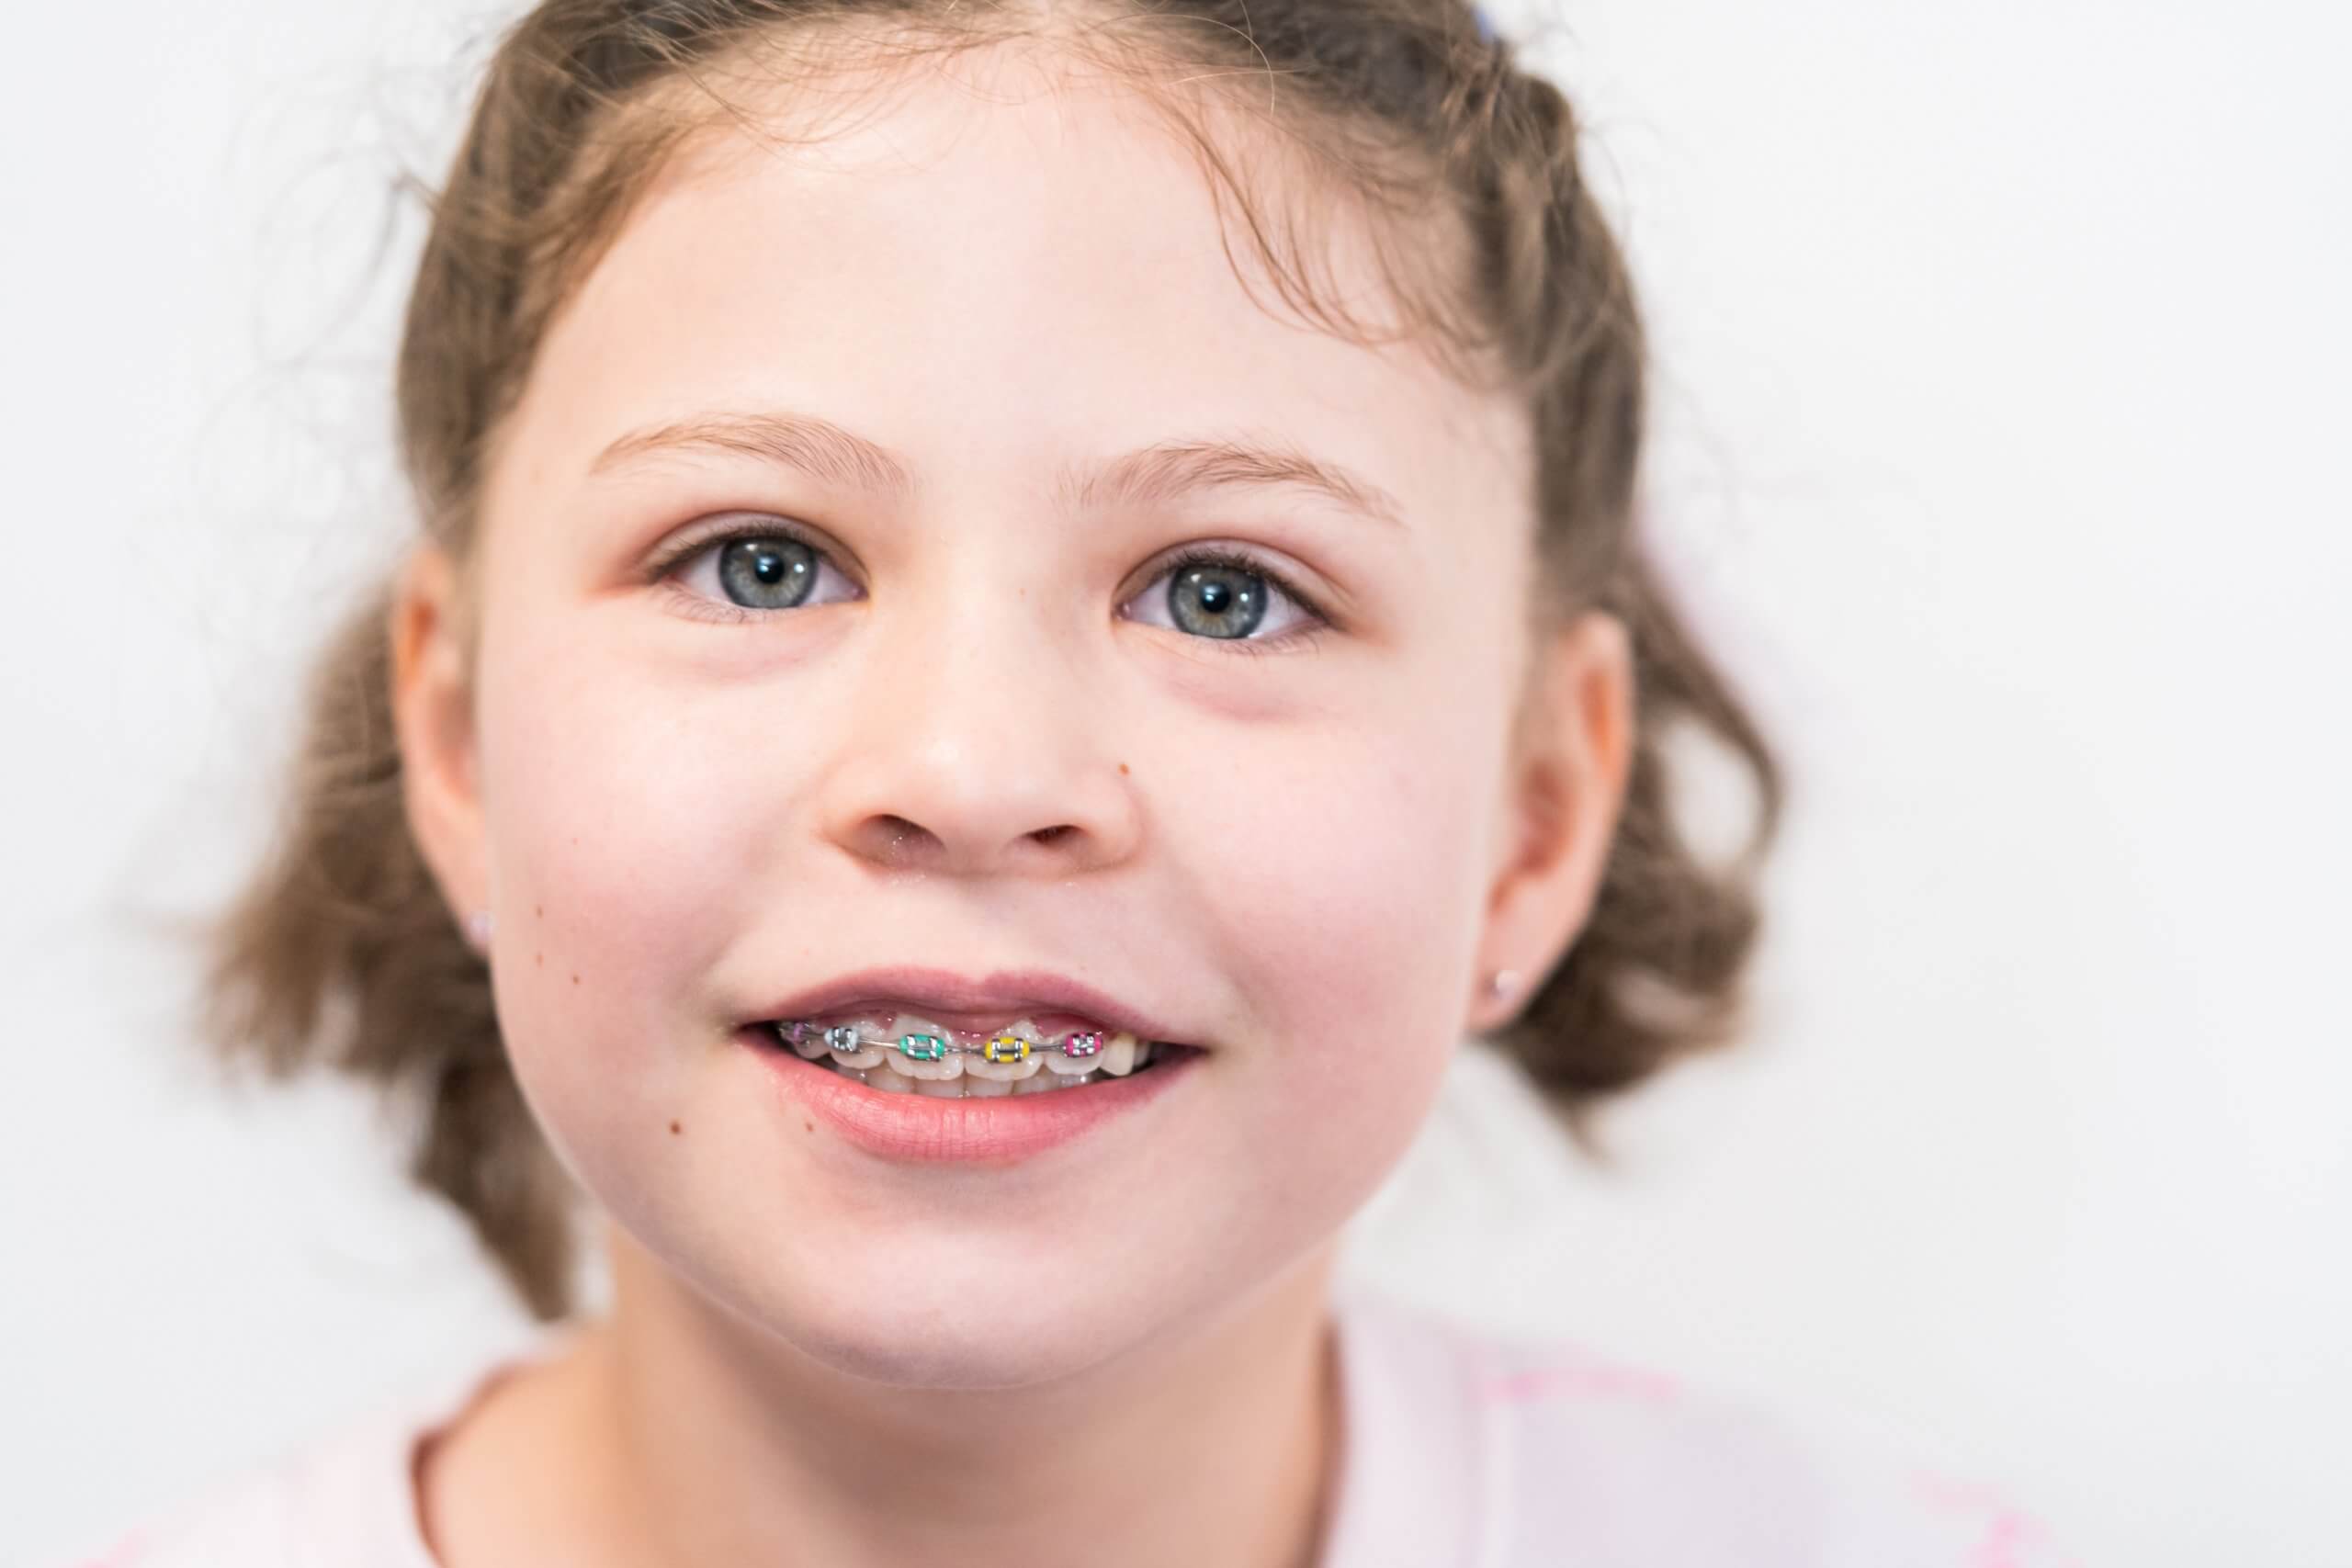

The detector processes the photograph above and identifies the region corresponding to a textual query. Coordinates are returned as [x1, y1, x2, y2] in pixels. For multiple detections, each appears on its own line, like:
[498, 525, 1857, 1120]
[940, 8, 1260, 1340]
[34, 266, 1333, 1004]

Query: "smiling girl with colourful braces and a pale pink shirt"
[64, 0, 2069, 1568]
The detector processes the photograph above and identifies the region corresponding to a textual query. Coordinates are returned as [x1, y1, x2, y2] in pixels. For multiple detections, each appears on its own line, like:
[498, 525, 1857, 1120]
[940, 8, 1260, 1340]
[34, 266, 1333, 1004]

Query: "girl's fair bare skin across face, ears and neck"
[390, 33, 1633, 1568]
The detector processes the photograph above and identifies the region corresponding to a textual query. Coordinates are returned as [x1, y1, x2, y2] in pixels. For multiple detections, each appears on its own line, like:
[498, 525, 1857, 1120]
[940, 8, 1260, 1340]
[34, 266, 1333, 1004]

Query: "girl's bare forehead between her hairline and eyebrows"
[510, 35, 1526, 517]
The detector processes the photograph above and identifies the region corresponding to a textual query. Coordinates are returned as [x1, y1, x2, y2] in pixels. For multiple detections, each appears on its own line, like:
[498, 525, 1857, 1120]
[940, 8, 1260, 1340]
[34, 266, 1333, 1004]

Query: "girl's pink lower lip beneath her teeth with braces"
[743, 1030, 1204, 1164]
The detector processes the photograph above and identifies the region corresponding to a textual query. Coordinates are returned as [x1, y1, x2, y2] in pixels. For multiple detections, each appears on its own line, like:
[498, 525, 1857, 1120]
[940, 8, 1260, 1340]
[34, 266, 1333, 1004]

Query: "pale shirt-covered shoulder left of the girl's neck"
[35, 1336, 573, 1568]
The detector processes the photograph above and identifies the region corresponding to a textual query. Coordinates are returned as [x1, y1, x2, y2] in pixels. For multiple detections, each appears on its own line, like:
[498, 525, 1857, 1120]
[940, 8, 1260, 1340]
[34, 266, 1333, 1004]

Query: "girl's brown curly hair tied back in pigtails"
[202, 0, 1781, 1319]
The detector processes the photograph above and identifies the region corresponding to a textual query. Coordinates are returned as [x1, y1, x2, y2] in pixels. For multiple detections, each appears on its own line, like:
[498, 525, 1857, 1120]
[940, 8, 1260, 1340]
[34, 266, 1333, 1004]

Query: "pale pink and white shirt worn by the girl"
[51, 1288, 2079, 1568]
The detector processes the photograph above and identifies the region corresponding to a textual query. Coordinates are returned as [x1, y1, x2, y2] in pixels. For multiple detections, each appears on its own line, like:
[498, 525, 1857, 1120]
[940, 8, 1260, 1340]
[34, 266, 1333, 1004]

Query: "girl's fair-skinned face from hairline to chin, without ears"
[435, 46, 1580, 1387]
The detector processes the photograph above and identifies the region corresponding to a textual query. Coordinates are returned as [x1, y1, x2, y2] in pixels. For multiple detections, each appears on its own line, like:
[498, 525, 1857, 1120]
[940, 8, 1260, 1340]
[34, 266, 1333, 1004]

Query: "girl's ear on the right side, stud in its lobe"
[1465, 611, 1634, 1034]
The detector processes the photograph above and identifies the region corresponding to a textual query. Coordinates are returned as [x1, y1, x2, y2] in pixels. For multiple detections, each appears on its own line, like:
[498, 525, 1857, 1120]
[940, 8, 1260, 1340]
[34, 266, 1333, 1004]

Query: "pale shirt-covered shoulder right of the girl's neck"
[1331, 1295, 2079, 1568]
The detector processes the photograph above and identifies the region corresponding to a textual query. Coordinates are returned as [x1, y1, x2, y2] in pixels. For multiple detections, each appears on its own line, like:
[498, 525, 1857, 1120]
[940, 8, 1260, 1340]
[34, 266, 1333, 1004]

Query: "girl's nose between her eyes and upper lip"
[823, 569, 1138, 877]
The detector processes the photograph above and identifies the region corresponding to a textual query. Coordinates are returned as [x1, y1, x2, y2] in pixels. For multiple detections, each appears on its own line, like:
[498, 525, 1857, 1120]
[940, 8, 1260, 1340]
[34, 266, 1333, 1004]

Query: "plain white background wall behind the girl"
[0, 0, 2352, 1568]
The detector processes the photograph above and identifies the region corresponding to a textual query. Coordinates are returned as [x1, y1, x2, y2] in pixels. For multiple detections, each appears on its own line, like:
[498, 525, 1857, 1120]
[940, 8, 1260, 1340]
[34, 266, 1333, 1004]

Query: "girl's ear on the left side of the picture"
[386, 543, 489, 921]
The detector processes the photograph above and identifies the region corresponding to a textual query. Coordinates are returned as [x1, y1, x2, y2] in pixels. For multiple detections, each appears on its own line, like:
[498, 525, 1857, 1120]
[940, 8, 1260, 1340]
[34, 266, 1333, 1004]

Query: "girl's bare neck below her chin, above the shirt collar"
[545, 1229, 1340, 1568]
